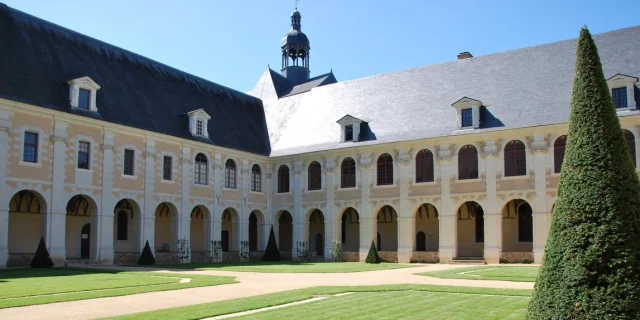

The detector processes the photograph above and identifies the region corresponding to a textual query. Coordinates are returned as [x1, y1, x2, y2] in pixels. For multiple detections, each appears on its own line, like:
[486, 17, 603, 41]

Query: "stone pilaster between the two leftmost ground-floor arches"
[45, 121, 69, 266]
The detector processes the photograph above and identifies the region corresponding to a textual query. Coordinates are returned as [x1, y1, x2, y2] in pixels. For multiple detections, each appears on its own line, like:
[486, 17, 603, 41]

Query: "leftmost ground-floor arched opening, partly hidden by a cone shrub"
[7, 190, 49, 267]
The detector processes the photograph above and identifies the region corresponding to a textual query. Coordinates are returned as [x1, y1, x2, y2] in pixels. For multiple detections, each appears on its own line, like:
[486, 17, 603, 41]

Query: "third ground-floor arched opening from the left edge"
[113, 199, 142, 264]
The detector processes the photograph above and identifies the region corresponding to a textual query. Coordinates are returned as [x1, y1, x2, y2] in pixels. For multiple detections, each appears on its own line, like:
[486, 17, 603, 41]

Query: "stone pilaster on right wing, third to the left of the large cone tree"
[438, 144, 457, 263]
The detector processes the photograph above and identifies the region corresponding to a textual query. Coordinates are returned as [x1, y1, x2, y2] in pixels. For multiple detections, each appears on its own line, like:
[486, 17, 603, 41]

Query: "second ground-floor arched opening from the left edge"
[65, 195, 97, 260]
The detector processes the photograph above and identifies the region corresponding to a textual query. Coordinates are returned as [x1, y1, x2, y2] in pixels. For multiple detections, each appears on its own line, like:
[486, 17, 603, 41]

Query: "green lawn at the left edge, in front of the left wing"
[0, 268, 236, 308]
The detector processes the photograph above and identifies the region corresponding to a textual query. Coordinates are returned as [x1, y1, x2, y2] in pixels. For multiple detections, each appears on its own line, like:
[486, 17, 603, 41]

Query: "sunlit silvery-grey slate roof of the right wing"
[251, 26, 640, 156]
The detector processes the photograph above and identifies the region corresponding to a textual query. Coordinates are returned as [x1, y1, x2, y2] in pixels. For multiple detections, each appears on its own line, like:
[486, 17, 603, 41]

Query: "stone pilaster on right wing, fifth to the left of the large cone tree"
[358, 154, 377, 262]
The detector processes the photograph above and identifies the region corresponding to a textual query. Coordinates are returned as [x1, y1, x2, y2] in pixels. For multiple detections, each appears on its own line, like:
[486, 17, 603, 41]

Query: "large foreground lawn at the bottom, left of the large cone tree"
[110, 285, 531, 320]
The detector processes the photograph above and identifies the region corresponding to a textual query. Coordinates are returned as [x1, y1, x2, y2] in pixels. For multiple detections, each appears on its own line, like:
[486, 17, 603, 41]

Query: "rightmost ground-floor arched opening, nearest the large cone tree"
[500, 199, 533, 262]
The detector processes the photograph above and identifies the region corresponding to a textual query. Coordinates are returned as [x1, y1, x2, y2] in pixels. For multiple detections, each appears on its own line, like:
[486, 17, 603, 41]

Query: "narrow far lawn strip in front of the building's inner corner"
[147, 261, 412, 273]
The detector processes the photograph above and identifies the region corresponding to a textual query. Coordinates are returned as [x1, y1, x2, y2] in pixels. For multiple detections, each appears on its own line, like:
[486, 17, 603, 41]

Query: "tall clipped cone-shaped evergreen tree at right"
[526, 28, 640, 319]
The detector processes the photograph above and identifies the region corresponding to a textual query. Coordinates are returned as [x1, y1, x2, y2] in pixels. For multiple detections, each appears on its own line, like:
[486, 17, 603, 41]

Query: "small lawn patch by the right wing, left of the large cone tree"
[419, 266, 540, 282]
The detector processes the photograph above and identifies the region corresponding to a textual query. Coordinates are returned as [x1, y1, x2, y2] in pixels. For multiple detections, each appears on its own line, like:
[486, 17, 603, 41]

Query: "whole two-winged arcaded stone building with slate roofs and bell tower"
[0, 4, 640, 266]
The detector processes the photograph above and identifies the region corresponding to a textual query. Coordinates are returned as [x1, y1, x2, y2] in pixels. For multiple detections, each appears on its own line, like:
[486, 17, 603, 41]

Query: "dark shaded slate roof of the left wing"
[0, 3, 270, 155]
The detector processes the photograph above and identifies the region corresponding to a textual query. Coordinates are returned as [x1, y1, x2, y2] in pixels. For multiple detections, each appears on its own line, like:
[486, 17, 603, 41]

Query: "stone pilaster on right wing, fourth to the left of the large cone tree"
[396, 150, 416, 263]
